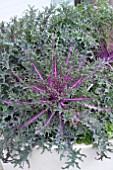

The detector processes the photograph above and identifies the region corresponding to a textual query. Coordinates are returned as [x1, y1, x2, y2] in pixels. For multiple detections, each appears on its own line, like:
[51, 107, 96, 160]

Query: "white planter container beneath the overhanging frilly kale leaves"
[2, 145, 113, 170]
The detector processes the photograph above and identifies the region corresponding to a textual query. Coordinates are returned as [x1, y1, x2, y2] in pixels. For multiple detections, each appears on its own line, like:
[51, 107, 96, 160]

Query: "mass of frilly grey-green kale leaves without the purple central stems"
[0, 1, 113, 168]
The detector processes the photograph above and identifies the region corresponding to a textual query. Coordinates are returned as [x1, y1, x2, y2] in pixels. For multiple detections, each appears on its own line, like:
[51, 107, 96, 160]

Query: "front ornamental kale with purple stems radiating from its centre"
[0, 40, 113, 168]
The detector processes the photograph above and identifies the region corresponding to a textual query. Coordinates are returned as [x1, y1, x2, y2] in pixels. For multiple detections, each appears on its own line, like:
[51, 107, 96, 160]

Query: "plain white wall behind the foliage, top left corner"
[0, 0, 51, 22]
